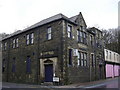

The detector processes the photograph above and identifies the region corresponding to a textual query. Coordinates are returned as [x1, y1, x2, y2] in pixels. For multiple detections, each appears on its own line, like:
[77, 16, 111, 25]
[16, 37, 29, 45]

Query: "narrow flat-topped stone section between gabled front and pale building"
[88, 27, 105, 80]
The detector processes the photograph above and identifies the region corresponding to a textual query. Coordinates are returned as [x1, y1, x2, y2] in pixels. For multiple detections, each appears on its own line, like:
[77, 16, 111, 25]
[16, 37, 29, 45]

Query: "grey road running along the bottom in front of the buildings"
[2, 77, 120, 90]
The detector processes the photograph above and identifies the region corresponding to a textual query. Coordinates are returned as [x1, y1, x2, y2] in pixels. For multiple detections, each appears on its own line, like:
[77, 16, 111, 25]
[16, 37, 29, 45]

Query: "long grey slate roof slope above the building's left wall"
[2, 13, 76, 40]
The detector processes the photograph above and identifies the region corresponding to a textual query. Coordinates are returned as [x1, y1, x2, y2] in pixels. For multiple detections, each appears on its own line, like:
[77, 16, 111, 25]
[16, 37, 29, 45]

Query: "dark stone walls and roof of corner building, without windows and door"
[2, 13, 104, 85]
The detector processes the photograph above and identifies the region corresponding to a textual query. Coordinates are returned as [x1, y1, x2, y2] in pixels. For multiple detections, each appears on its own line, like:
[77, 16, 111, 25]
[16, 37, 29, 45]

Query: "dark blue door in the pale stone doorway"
[45, 64, 53, 82]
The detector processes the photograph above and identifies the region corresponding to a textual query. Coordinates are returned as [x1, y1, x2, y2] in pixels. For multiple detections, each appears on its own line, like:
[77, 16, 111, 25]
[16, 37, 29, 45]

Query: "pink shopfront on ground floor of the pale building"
[106, 64, 120, 78]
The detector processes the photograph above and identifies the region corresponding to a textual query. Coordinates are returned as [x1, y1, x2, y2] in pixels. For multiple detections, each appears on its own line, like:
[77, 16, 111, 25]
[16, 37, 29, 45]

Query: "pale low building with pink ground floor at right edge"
[104, 49, 120, 78]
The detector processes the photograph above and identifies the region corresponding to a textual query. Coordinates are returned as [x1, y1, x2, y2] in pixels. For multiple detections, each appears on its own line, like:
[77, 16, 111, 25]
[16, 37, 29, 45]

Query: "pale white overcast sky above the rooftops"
[0, 0, 119, 34]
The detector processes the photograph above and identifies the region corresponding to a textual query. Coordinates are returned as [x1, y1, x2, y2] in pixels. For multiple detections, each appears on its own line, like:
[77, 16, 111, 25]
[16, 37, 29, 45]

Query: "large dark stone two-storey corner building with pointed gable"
[2, 12, 104, 84]
